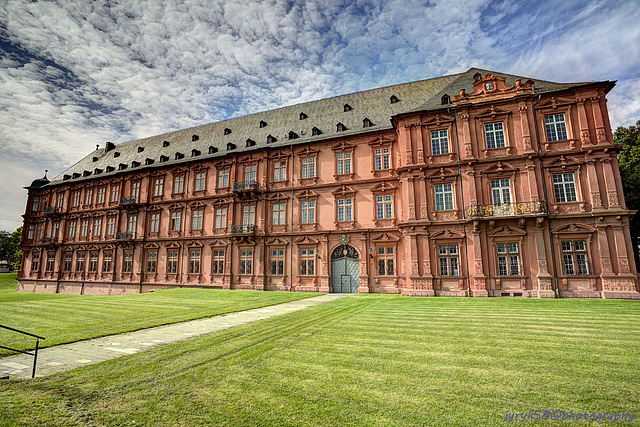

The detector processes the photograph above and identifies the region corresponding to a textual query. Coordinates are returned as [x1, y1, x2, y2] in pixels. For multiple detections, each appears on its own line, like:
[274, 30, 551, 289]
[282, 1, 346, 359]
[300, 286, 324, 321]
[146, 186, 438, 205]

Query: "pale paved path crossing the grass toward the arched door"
[0, 294, 352, 378]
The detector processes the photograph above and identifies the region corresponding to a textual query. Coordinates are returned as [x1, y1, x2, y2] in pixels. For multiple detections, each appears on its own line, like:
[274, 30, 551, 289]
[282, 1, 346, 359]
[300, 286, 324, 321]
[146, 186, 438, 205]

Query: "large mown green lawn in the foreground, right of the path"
[0, 295, 640, 426]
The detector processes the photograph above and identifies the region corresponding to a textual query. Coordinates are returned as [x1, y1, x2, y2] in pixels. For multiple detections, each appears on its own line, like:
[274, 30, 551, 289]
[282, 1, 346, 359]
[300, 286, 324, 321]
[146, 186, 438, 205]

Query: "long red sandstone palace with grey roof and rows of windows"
[18, 68, 640, 298]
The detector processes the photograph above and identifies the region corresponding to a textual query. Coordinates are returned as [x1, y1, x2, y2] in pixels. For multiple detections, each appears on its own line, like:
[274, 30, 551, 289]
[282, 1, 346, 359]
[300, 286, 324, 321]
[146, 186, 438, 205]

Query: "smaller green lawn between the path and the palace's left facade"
[0, 273, 319, 355]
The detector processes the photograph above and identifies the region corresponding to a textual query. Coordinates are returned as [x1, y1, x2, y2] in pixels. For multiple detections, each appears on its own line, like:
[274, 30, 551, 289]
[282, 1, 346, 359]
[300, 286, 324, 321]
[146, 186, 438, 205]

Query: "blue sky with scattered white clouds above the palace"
[0, 0, 640, 230]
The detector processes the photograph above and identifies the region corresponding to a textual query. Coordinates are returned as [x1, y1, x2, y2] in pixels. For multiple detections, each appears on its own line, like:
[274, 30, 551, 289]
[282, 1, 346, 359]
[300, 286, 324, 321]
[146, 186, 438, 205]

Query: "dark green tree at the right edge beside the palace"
[613, 120, 640, 257]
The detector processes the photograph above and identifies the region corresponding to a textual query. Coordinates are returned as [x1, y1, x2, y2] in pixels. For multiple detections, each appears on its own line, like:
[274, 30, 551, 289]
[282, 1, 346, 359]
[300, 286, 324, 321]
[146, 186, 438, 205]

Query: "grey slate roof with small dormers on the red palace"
[46, 68, 608, 185]
